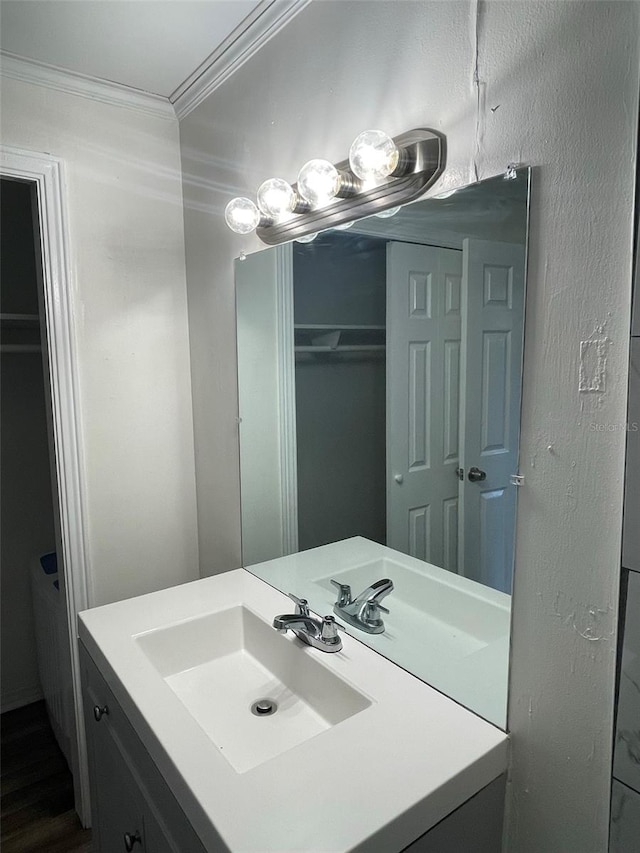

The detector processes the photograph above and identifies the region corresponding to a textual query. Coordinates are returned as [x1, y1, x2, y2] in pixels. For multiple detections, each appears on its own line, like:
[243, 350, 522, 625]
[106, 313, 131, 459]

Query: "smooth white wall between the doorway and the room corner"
[2, 78, 198, 605]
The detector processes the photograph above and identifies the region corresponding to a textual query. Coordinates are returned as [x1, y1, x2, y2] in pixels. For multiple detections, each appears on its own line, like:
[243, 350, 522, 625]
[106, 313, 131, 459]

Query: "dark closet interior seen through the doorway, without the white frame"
[0, 177, 85, 832]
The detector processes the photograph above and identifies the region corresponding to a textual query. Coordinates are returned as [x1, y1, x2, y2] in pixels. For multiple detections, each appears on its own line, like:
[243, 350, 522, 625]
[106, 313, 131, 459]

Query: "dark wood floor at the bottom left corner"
[0, 702, 91, 853]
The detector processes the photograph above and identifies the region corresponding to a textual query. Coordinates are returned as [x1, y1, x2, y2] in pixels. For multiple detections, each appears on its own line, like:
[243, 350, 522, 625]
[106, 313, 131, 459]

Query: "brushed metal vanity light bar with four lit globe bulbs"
[225, 128, 446, 245]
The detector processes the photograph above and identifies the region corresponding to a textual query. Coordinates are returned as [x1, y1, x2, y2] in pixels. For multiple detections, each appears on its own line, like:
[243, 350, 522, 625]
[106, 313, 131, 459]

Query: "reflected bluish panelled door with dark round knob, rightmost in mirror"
[460, 240, 524, 592]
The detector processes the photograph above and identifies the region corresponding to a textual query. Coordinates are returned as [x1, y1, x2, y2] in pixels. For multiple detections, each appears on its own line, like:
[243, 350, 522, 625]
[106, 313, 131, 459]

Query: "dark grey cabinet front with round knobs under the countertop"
[80, 645, 206, 853]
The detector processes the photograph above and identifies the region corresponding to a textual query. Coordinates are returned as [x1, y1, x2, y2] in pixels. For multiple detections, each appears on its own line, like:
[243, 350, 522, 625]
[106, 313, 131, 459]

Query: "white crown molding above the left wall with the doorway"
[0, 51, 176, 121]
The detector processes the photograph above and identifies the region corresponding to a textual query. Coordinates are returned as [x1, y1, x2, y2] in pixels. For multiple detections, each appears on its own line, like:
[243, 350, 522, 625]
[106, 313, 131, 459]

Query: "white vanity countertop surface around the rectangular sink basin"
[79, 569, 508, 853]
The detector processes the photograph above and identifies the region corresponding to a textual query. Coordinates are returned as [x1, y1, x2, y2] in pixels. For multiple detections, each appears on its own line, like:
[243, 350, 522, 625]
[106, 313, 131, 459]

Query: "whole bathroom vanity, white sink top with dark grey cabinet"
[79, 569, 508, 853]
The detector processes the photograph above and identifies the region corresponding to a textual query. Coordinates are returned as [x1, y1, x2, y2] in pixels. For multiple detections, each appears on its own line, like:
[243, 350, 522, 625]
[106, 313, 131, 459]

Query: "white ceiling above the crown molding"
[0, 0, 268, 98]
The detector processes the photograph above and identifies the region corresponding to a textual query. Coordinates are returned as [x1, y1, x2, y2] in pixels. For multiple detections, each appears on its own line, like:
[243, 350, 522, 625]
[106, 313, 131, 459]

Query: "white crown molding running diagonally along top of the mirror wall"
[169, 0, 311, 119]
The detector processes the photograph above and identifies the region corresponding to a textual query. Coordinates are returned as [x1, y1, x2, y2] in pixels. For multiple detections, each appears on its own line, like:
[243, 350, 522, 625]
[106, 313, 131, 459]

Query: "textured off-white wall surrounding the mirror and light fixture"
[181, 0, 639, 853]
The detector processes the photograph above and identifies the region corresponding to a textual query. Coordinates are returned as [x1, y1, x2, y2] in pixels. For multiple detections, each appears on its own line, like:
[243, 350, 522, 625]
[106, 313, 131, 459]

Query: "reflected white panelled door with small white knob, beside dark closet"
[387, 243, 462, 571]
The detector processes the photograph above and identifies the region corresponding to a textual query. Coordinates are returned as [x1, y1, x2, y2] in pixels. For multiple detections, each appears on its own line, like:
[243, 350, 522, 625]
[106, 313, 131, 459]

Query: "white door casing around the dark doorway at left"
[0, 147, 91, 825]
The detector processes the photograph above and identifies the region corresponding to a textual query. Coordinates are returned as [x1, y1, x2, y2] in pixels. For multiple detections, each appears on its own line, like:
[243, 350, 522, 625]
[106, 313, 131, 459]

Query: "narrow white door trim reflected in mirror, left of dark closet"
[276, 243, 298, 556]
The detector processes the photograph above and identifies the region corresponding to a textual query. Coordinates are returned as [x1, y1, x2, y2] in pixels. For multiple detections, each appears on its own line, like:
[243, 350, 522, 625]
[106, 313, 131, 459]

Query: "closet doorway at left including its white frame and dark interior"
[0, 147, 90, 826]
